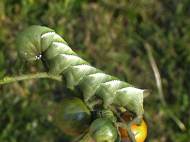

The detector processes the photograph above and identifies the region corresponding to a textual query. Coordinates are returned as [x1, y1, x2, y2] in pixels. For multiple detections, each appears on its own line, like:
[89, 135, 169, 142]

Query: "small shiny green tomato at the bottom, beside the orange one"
[89, 118, 118, 142]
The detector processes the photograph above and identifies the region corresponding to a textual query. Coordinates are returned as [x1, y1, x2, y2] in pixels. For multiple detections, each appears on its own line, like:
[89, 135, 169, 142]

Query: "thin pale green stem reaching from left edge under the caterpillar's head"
[0, 72, 62, 85]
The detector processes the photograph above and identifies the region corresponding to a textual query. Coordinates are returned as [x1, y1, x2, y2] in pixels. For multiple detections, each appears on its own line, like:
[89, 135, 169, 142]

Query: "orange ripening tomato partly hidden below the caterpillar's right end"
[119, 113, 147, 142]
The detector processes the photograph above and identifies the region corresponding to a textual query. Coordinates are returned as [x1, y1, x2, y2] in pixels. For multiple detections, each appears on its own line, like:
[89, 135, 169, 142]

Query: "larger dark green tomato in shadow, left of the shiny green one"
[52, 97, 91, 136]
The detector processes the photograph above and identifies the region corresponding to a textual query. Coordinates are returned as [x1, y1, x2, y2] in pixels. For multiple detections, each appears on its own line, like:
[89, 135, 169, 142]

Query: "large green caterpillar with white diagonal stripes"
[16, 25, 146, 121]
